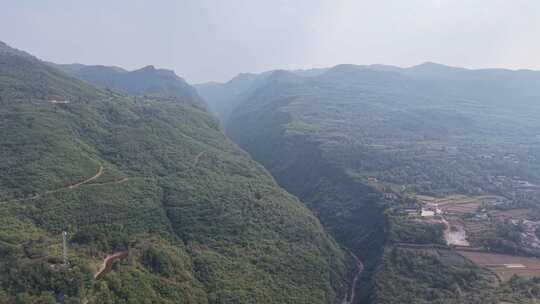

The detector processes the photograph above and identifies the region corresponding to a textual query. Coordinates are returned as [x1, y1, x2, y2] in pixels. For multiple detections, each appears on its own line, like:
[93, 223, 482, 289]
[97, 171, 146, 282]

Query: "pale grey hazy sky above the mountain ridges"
[0, 0, 540, 83]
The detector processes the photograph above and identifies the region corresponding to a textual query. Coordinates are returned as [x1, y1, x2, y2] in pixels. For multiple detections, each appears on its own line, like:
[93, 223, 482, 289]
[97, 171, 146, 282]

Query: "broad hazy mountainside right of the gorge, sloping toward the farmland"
[199, 63, 540, 304]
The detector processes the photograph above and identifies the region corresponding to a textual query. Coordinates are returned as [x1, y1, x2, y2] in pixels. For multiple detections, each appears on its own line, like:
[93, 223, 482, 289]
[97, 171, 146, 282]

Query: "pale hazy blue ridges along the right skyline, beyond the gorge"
[195, 62, 540, 122]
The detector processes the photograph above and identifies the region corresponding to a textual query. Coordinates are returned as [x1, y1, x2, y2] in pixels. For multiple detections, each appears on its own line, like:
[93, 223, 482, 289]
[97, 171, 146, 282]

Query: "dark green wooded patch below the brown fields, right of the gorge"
[371, 247, 497, 304]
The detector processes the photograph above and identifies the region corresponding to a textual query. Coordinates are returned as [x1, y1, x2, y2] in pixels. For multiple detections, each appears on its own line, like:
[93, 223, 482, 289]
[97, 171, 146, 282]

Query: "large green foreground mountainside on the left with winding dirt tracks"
[0, 44, 354, 304]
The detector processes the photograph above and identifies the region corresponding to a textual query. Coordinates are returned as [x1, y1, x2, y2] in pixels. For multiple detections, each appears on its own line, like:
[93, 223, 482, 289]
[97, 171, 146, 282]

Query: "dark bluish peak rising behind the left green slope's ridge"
[52, 64, 204, 107]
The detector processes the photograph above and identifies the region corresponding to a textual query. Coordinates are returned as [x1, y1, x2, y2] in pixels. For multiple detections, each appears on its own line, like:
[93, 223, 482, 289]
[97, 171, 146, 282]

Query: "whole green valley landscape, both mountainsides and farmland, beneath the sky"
[0, 34, 540, 304]
